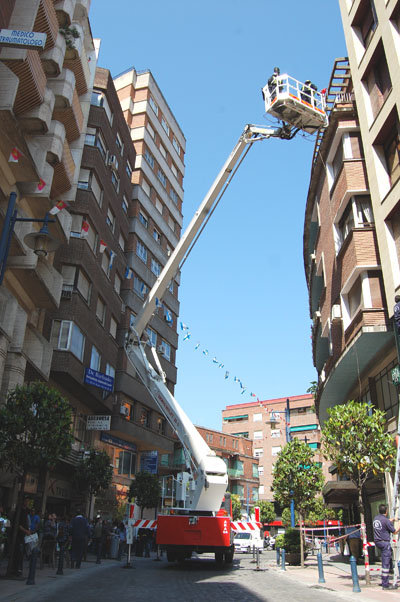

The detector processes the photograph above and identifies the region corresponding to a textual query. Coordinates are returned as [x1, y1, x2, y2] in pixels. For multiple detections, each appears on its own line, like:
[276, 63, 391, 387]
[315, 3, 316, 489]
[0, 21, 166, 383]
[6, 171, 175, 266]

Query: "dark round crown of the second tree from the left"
[74, 449, 113, 495]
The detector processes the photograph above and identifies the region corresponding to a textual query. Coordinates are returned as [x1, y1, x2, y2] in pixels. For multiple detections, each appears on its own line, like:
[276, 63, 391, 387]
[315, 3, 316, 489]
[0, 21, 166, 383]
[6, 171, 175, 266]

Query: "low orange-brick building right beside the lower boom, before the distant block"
[196, 426, 260, 504]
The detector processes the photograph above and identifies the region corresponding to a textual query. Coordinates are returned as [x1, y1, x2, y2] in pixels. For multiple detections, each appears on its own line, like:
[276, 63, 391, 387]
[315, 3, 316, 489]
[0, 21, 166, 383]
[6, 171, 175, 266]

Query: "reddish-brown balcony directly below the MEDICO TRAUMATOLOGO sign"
[0, 48, 46, 115]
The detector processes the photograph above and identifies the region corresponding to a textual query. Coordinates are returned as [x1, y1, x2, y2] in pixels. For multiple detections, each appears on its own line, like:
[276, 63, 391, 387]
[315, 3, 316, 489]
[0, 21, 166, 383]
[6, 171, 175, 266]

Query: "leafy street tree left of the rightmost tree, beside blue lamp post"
[272, 439, 324, 566]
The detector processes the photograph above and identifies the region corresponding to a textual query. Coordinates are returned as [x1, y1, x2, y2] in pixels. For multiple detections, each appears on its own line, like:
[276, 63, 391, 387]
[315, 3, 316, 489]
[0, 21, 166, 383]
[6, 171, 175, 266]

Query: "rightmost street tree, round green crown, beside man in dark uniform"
[321, 401, 396, 579]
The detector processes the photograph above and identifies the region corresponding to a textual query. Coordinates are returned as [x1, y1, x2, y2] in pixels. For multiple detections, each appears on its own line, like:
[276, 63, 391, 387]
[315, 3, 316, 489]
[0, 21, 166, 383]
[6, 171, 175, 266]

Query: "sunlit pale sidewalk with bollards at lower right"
[268, 554, 400, 602]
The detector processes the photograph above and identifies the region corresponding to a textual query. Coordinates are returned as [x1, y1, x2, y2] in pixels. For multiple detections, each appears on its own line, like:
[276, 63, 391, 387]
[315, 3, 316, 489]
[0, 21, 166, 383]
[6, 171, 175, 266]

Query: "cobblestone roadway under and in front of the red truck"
[0, 554, 356, 602]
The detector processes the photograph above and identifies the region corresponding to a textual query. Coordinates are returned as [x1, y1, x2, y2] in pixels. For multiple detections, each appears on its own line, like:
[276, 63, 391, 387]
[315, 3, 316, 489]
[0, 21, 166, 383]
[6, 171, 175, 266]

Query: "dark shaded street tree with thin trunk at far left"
[0, 382, 72, 575]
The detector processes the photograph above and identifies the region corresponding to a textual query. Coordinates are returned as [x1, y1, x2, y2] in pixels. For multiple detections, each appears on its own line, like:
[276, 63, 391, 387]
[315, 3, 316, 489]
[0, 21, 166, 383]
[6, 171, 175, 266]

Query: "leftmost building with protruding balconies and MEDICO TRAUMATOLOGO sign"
[0, 0, 96, 503]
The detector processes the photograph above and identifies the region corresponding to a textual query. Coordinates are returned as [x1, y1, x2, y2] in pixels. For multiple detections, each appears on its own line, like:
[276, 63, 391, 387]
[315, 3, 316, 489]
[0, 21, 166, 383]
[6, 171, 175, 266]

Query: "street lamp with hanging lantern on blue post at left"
[0, 192, 61, 285]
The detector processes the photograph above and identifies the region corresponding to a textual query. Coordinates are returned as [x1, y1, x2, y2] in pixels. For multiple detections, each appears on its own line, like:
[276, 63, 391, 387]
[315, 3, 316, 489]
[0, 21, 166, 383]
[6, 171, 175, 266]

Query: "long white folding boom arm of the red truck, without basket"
[126, 125, 292, 512]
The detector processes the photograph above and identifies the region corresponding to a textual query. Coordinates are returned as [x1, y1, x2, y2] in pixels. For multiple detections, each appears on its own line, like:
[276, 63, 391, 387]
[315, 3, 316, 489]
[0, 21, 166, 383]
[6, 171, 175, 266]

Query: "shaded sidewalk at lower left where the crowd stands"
[0, 554, 127, 602]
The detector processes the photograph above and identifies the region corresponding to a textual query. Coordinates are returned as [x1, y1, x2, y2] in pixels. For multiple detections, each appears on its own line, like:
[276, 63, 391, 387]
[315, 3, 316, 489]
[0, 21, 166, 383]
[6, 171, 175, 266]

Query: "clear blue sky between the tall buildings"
[90, 0, 346, 429]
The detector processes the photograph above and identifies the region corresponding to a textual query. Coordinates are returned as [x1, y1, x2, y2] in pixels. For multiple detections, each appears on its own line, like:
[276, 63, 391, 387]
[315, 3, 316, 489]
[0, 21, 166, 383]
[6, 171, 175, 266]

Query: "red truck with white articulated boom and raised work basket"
[125, 74, 327, 564]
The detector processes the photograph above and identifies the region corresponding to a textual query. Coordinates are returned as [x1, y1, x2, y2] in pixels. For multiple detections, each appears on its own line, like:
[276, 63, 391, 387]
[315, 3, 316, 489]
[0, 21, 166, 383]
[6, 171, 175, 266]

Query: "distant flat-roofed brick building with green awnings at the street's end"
[222, 394, 329, 501]
